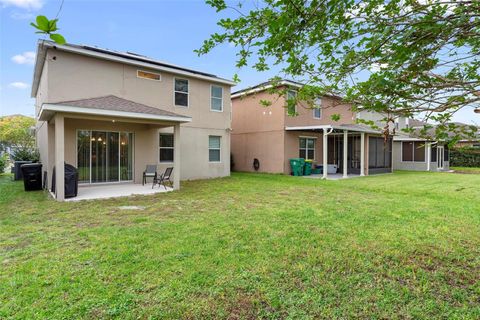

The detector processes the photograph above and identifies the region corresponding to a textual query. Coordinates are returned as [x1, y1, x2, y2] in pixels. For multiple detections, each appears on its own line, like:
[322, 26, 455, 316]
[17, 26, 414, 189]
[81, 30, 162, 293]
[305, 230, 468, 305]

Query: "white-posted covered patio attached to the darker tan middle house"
[285, 124, 391, 180]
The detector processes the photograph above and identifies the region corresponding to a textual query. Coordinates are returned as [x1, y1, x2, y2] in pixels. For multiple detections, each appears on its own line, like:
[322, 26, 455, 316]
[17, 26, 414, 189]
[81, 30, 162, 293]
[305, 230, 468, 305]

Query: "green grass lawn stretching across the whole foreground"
[0, 172, 480, 319]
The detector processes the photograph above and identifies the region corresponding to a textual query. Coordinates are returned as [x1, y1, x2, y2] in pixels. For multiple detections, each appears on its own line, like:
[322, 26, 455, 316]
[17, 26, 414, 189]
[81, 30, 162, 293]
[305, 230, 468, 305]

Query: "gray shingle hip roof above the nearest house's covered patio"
[51, 95, 189, 119]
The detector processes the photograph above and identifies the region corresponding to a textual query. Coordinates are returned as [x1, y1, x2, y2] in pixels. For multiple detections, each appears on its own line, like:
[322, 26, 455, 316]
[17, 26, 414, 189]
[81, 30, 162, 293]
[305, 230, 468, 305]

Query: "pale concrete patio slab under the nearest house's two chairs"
[65, 183, 173, 201]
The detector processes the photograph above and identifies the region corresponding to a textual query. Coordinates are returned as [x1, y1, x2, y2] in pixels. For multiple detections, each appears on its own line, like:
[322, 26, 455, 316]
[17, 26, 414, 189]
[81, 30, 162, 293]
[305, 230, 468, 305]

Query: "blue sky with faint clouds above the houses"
[0, 0, 480, 124]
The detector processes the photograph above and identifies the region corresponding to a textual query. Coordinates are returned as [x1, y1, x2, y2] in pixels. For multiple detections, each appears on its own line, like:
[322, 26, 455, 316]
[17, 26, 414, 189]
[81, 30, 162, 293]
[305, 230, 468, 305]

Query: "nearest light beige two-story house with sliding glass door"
[32, 40, 234, 200]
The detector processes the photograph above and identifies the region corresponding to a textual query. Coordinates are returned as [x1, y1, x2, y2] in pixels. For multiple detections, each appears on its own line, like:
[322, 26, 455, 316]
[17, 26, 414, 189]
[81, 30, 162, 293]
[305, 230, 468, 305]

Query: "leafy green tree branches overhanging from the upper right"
[197, 0, 480, 139]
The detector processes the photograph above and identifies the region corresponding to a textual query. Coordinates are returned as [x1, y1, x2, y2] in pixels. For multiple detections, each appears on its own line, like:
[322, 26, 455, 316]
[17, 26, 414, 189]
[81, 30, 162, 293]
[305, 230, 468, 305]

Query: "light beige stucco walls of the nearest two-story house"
[36, 49, 231, 182]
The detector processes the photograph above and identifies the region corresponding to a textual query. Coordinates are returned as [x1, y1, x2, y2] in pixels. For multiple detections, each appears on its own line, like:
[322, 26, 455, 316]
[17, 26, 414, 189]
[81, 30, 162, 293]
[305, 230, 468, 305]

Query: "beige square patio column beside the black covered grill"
[55, 114, 65, 201]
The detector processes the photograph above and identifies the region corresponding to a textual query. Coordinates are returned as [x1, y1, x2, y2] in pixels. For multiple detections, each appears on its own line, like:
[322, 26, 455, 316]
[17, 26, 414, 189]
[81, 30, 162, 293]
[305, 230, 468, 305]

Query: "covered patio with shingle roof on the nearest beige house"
[39, 96, 191, 201]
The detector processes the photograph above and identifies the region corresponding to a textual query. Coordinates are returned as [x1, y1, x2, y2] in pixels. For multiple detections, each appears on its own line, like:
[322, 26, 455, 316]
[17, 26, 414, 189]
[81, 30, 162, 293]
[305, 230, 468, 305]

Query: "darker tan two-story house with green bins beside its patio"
[231, 80, 392, 178]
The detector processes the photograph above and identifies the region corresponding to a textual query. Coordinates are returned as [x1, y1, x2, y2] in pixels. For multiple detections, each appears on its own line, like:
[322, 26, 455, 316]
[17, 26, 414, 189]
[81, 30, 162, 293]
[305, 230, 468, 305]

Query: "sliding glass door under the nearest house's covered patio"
[77, 130, 133, 183]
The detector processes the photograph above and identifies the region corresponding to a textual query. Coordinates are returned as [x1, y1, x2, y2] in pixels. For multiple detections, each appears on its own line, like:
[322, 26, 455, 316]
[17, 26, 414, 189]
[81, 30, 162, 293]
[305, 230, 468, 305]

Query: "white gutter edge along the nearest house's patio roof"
[39, 103, 192, 122]
